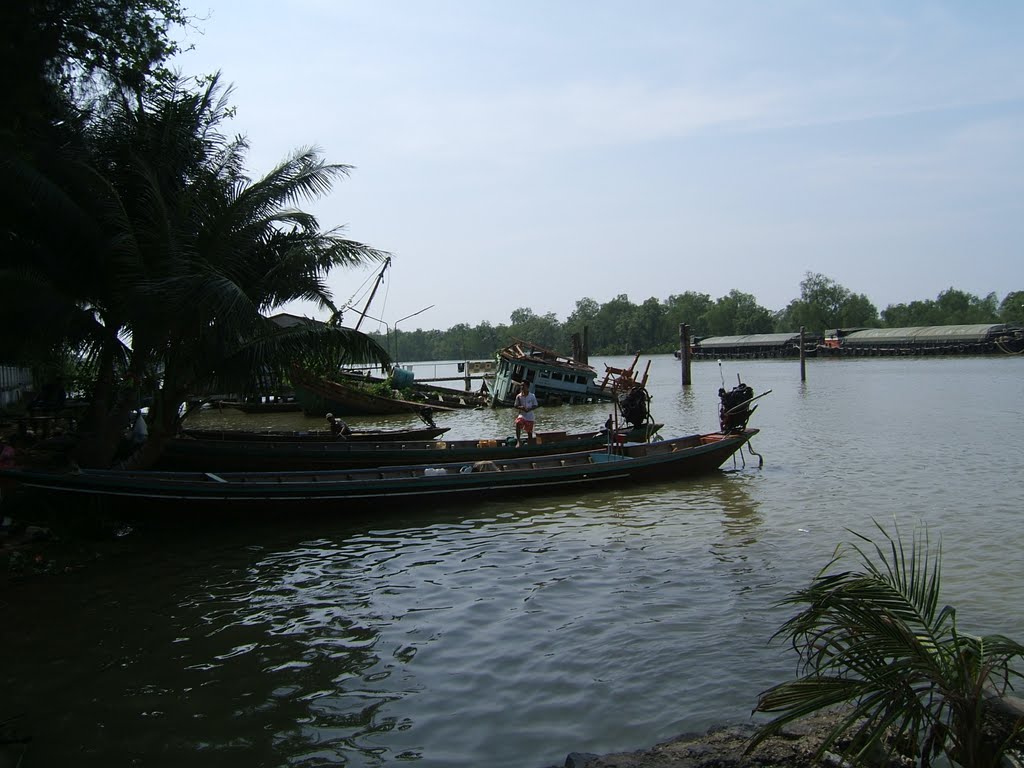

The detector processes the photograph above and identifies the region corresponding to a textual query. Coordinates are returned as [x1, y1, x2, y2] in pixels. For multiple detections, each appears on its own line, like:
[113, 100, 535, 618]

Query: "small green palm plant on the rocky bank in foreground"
[748, 523, 1024, 768]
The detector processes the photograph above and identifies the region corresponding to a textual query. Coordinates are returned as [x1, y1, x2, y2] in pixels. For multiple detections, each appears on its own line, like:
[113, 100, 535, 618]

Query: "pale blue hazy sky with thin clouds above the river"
[173, 0, 1024, 331]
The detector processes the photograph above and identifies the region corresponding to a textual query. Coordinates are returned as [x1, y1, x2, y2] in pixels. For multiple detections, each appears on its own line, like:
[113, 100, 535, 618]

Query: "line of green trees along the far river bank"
[371, 272, 1024, 362]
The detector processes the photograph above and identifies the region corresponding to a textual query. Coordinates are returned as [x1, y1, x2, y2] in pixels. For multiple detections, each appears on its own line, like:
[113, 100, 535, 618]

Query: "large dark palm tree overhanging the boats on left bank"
[0, 78, 390, 465]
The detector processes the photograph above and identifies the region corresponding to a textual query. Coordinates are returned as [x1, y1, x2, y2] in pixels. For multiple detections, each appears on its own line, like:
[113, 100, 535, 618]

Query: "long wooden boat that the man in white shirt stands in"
[158, 424, 662, 472]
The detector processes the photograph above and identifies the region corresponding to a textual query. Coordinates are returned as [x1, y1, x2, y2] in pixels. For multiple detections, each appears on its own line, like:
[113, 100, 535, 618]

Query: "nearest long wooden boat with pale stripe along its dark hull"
[0, 429, 758, 516]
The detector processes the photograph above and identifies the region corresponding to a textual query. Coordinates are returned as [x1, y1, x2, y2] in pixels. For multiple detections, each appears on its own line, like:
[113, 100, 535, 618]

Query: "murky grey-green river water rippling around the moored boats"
[0, 355, 1024, 768]
